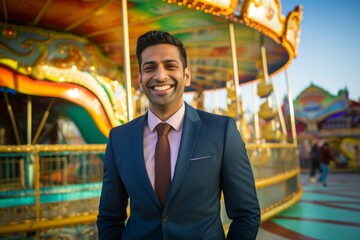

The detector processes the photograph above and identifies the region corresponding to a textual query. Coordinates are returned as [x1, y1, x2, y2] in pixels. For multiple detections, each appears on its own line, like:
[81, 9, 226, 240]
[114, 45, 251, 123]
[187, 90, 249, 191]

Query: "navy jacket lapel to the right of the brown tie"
[167, 103, 201, 201]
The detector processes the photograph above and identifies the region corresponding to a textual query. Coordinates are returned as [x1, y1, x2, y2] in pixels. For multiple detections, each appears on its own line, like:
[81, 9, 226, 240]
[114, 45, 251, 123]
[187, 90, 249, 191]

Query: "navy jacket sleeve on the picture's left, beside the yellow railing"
[97, 131, 128, 240]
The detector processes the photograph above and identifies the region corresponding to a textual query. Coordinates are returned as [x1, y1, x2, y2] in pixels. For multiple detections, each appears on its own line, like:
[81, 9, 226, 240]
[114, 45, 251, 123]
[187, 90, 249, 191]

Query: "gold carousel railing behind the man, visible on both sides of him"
[0, 144, 302, 237]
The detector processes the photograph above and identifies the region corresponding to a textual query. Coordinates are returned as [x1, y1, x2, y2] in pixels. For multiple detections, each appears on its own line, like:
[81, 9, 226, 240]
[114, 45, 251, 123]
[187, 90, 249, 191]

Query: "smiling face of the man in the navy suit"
[138, 44, 190, 110]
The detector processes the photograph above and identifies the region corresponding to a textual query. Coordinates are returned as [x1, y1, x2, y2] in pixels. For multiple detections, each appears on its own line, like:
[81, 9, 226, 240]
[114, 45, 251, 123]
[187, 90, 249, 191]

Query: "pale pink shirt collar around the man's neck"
[148, 103, 185, 132]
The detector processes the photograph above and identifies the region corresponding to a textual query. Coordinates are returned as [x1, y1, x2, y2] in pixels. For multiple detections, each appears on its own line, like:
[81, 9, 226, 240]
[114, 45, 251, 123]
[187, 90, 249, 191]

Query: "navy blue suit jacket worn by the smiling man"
[97, 103, 260, 240]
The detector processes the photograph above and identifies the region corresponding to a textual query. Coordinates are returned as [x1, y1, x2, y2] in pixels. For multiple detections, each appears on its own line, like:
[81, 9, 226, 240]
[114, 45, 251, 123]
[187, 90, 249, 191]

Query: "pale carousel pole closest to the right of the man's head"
[229, 22, 241, 122]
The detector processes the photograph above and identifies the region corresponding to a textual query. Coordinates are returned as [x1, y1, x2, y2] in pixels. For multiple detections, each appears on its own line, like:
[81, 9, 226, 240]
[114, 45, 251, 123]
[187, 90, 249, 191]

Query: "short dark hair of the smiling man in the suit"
[136, 31, 187, 69]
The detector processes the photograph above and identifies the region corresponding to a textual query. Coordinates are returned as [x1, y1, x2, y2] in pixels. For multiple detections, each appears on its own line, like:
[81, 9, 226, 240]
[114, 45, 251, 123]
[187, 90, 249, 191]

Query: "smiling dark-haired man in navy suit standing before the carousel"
[97, 31, 260, 240]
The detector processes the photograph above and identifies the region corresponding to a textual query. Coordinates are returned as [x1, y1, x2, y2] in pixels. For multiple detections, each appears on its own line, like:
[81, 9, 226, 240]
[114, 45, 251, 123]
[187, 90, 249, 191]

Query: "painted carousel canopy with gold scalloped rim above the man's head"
[0, 0, 302, 90]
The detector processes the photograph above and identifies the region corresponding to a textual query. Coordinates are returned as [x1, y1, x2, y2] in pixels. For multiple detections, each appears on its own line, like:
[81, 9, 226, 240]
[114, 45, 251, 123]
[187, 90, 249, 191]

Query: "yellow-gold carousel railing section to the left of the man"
[0, 144, 105, 235]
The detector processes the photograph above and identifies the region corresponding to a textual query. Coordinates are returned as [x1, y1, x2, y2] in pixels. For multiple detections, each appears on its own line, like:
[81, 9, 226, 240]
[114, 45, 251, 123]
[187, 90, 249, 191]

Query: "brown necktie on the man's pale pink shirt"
[155, 123, 171, 205]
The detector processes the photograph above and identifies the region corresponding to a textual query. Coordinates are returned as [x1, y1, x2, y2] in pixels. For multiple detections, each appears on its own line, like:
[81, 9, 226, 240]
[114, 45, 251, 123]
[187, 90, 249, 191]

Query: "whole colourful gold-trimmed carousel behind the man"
[0, 0, 302, 237]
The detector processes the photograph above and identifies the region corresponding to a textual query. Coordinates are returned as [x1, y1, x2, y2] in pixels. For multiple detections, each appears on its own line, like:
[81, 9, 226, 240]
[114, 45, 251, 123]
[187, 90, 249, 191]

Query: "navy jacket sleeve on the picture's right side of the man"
[221, 118, 260, 240]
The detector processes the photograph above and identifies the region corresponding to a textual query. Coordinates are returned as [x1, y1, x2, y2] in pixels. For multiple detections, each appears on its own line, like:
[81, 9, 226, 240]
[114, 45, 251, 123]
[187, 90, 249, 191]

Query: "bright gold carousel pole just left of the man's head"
[121, 0, 133, 121]
